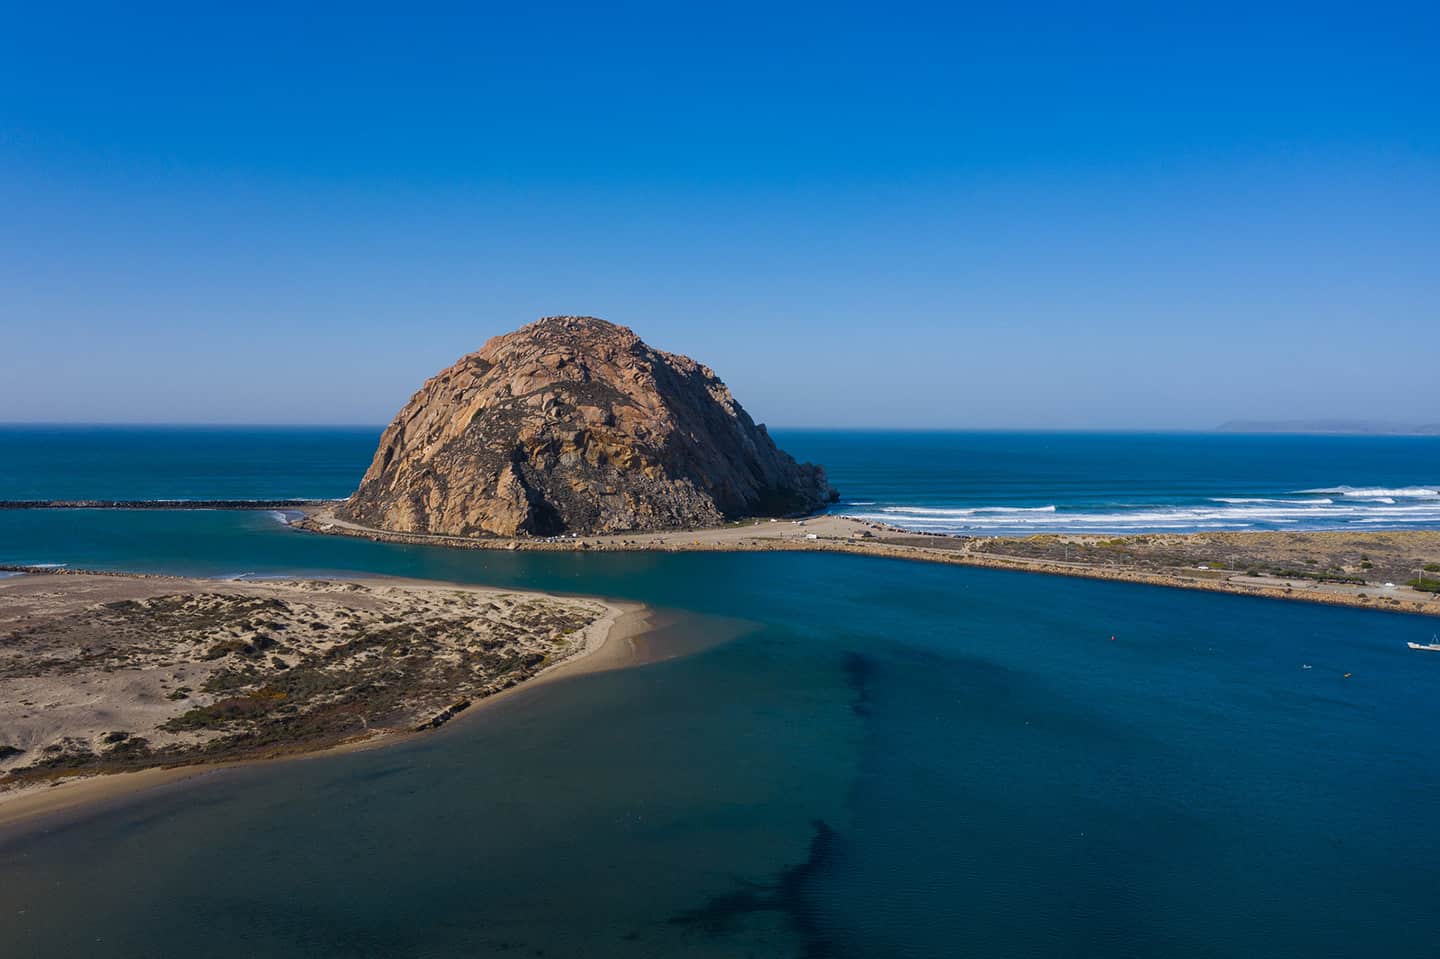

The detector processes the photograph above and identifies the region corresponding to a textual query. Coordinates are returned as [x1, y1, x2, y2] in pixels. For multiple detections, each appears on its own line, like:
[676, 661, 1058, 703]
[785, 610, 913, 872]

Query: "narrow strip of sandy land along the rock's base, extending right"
[295, 507, 1440, 616]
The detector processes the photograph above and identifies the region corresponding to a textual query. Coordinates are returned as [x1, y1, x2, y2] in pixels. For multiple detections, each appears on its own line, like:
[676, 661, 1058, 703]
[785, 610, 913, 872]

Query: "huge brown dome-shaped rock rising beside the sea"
[340, 317, 835, 536]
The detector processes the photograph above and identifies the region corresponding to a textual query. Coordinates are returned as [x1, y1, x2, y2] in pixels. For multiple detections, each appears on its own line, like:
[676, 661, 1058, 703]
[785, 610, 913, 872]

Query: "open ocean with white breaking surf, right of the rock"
[776, 431, 1440, 536]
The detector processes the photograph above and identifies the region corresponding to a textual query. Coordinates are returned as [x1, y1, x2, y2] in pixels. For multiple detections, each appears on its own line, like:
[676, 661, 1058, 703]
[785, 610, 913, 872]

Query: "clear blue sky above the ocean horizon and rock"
[0, 3, 1440, 428]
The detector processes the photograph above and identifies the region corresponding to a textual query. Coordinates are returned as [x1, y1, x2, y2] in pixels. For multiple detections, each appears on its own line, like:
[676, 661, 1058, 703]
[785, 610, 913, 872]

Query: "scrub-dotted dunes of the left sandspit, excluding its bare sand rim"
[0, 575, 606, 789]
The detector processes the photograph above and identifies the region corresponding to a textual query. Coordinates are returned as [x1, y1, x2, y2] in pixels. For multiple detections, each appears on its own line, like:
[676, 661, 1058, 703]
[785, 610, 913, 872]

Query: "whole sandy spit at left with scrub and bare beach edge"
[0, 572, 642, 827]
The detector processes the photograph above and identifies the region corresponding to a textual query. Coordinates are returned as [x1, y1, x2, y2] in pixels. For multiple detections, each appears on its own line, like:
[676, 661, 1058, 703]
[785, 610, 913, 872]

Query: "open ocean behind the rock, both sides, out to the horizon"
[0, 426, 1440, 534]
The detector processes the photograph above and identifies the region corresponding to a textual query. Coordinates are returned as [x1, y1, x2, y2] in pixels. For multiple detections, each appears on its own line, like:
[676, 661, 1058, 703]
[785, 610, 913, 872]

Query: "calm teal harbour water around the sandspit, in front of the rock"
[0, 436, 1440, 959]
